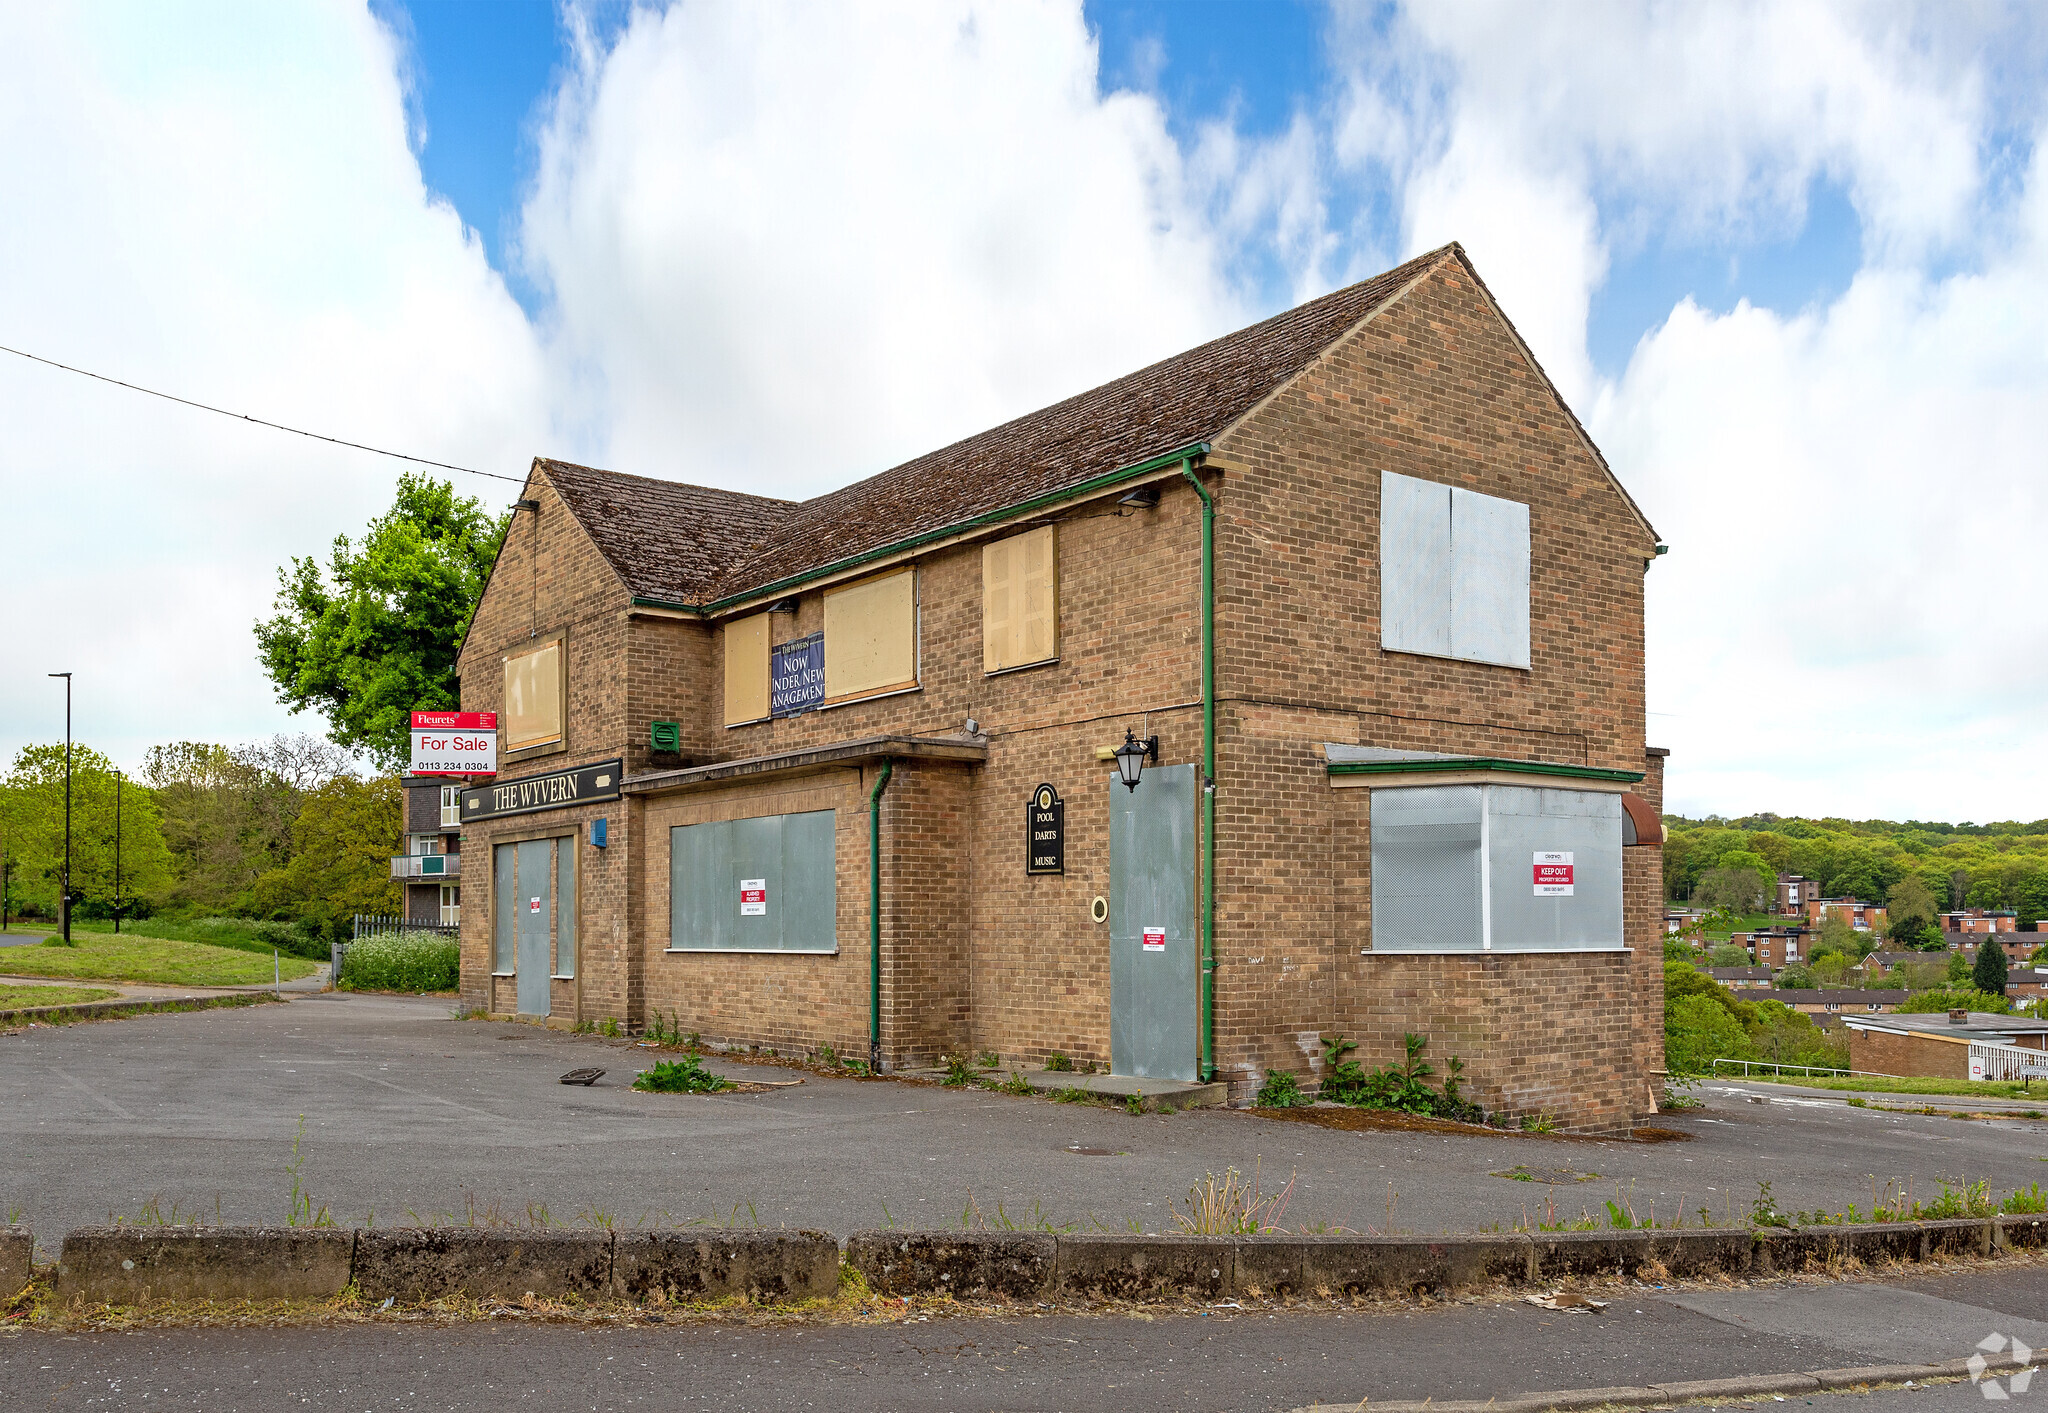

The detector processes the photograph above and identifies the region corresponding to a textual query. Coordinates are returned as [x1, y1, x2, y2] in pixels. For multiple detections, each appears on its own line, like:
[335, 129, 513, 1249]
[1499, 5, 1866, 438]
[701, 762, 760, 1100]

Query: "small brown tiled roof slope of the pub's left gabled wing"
[535, 459, 797, 604]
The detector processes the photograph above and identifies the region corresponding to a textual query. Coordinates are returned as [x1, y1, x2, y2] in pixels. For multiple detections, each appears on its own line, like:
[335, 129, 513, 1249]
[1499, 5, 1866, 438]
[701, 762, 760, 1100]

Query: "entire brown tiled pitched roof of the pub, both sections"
[535, 246, 1456, 604]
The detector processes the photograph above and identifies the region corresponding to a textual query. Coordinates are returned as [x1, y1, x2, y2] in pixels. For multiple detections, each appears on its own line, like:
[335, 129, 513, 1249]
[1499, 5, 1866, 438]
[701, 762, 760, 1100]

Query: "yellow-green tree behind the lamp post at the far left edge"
[0, 741, 170, 915]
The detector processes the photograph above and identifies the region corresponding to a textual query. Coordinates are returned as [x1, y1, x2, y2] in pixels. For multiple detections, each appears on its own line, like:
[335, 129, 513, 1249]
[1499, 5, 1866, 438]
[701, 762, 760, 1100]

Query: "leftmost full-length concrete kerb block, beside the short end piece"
[57, 1227, 356, 1304]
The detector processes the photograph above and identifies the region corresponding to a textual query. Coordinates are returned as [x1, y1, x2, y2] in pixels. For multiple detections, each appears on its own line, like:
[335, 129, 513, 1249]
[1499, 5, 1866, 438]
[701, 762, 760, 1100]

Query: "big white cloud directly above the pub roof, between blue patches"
[512, 0, 1253, 496]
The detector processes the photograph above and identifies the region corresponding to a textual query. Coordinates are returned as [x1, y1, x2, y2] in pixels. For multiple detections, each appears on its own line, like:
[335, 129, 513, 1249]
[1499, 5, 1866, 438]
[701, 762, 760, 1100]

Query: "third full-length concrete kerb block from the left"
[612, 1231, 840, 1300]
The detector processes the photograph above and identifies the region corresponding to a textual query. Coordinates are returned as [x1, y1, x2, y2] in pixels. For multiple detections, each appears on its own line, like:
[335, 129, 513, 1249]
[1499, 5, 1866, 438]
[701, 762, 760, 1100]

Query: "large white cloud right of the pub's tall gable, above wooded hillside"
[1333, 4, 2048, 819]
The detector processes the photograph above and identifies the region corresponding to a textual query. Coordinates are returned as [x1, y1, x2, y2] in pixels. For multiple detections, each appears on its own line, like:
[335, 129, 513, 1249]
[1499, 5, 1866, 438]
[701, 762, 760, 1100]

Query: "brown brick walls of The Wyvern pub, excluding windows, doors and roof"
[463, 262, 1663, 1130]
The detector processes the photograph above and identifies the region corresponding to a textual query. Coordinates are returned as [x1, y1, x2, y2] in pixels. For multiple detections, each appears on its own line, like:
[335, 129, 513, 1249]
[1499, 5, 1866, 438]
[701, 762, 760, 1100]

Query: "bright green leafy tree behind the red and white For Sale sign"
[256, 473, 508, 770]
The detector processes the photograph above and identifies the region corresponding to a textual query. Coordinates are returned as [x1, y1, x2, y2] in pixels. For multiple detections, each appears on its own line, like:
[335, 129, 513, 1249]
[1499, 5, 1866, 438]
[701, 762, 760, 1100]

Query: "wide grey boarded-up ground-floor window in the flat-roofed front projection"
[668, 809, 840, 952]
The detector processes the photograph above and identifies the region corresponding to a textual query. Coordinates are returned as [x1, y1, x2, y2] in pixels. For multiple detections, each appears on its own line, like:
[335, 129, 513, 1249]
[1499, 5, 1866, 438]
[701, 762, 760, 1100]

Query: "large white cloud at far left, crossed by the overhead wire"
[0, 4, 547, 764]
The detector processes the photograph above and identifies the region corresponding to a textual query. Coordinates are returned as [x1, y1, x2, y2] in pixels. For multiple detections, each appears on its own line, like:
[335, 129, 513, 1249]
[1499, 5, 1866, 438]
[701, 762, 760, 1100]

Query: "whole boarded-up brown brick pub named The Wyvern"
[448, 246, 1663, 1132]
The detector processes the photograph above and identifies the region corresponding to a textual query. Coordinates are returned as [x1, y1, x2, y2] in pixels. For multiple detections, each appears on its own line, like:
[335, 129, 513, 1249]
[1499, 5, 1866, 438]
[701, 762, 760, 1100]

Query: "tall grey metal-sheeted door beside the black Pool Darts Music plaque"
[1108, 766, 1200, 1079]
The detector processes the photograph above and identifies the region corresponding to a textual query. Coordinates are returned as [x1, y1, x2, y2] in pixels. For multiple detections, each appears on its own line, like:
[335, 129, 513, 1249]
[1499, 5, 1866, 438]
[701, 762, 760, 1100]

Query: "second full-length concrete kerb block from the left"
[354, 1227, 612, 1300]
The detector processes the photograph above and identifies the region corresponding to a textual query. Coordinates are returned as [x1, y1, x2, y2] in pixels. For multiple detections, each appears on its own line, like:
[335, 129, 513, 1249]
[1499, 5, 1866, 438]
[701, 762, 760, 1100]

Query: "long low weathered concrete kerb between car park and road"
[24, 1216, 2048, 1304]
